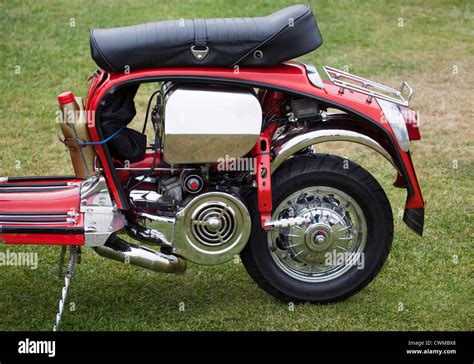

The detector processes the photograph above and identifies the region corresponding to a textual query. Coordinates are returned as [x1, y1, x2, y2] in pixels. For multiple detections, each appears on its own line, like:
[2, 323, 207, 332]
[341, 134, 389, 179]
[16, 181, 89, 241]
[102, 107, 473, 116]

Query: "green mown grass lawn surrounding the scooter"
[0, 0, 474, 330]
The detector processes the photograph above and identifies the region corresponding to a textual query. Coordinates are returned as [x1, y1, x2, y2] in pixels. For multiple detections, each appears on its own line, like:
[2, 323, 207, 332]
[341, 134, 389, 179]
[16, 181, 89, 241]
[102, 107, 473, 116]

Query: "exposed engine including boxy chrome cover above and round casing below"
[122, 83, 262, 265]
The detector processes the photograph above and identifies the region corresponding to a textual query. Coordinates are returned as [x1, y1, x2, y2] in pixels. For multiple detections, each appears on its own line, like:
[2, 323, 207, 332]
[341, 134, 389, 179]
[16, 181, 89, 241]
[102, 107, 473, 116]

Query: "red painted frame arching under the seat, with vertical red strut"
[86, 62, 424, 232]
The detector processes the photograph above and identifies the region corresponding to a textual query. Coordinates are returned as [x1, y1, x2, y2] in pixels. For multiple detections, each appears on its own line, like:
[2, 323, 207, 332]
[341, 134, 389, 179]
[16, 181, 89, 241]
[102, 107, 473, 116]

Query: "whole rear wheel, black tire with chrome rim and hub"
[241, 154, 393, 303]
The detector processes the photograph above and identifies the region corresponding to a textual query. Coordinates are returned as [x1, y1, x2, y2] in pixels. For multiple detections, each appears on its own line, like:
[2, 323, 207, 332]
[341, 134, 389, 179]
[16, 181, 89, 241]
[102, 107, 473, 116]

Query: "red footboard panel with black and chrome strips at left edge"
[0, 177, 84, 245]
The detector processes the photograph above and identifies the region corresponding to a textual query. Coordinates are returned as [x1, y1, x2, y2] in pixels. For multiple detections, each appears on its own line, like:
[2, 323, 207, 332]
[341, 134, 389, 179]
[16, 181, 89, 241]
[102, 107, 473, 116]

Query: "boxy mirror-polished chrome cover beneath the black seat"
[162, 84, 262, 164]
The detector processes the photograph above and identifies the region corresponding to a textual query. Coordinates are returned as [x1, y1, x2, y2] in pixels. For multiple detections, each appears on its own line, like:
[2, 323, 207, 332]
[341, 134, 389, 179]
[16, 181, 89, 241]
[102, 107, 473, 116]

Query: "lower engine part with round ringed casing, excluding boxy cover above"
[127, 177, 251, 265]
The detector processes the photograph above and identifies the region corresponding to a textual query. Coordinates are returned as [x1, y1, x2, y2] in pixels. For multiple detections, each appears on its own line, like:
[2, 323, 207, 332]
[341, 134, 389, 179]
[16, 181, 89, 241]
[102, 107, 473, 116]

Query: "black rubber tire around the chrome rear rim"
[241, 154, 393, 303]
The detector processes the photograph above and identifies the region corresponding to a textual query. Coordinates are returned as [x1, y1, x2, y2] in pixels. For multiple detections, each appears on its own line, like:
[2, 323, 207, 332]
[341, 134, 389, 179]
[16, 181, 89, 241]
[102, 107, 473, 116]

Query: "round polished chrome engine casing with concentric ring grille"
[175, 192, 252, 265]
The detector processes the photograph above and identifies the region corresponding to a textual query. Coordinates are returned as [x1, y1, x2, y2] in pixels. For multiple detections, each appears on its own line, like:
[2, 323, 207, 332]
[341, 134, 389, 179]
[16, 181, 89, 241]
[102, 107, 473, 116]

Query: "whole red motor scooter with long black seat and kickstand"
[0, 5, 424, 328]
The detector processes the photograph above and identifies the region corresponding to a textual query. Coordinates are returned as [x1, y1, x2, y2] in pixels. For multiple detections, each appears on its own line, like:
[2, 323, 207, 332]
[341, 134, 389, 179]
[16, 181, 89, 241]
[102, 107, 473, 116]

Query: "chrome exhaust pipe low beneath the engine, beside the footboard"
[94, 237, 187, 273]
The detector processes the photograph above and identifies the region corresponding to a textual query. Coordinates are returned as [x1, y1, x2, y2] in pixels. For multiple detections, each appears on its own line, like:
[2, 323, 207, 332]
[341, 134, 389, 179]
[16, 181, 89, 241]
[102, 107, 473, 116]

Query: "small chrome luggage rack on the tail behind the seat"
[323, 66, 413, 106]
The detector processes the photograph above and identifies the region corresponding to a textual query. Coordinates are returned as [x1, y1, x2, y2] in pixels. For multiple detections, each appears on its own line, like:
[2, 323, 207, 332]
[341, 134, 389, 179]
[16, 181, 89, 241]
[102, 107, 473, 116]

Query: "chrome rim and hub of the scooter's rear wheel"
[268, 186, 367, 282]
